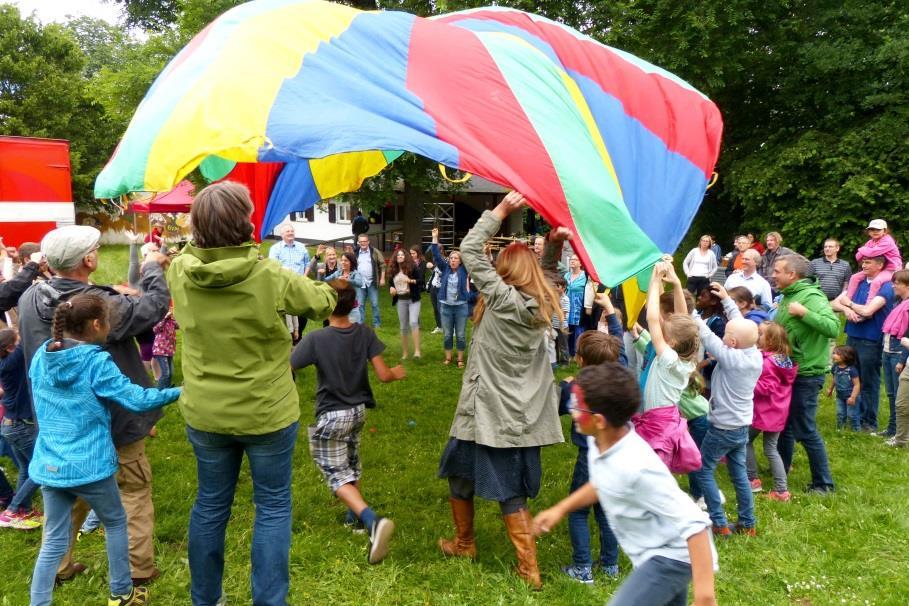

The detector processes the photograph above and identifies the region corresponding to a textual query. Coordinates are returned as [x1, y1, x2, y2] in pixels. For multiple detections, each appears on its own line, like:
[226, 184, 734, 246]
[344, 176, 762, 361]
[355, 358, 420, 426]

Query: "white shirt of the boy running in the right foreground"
[587, 424, 717, 570]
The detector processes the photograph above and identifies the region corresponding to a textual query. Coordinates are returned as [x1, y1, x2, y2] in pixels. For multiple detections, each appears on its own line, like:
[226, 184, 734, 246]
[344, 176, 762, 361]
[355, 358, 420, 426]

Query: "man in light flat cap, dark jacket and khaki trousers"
[19, 225, 170, 584]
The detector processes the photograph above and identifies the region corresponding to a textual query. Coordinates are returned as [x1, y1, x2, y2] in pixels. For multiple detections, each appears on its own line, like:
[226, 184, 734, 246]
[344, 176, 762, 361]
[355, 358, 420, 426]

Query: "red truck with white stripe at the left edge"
[0, 136, 76, 246]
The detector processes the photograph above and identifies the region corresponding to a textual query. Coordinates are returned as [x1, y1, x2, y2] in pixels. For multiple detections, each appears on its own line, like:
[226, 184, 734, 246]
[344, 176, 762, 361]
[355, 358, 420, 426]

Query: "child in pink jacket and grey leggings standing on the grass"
[745, 321, 798, 501]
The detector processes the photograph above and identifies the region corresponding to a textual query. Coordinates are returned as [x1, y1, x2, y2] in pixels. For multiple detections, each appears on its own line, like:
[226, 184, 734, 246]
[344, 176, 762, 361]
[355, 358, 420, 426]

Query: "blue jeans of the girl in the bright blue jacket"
[31, 476, 133, 606]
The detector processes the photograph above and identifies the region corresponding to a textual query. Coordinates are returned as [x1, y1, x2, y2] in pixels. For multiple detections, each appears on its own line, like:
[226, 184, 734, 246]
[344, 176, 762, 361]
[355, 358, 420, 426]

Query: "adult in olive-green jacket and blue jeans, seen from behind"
[167, 182, 337, 606]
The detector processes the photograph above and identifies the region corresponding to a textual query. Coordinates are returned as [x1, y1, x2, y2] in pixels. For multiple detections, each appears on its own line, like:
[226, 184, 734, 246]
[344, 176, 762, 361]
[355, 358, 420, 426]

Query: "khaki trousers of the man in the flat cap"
[57, 439, 155, 578]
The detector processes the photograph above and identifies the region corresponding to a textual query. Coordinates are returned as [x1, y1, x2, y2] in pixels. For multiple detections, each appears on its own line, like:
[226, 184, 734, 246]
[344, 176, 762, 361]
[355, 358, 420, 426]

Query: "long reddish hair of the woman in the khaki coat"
[473, 242, 565, 325]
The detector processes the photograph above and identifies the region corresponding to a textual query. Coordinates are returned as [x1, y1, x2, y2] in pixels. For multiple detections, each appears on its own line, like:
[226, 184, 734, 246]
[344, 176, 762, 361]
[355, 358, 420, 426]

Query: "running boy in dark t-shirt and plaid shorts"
[290, 280, 404, 564]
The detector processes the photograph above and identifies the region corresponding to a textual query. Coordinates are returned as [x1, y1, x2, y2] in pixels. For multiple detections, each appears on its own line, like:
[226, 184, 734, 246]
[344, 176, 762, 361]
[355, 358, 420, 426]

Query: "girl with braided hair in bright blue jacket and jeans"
[29, 294, 180, 606]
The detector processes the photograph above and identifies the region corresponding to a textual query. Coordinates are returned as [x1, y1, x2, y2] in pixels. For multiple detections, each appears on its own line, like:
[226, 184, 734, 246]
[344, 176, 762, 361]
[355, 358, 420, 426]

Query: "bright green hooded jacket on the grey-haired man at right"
[774, 276, 840, 377]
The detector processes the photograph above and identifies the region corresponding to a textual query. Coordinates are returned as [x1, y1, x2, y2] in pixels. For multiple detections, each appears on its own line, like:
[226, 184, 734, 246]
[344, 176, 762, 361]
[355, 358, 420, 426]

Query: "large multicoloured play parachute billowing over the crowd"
[95, 0, 722, 285]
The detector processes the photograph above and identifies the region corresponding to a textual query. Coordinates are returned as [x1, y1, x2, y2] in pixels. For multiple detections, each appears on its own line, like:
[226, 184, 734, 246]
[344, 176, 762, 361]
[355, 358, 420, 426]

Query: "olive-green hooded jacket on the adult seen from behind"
[167, 243, 338, 435]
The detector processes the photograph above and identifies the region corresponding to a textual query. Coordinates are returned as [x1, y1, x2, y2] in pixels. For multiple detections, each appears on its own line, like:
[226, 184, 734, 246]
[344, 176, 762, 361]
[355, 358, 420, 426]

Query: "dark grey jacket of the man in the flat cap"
[19, 263, 170, 448]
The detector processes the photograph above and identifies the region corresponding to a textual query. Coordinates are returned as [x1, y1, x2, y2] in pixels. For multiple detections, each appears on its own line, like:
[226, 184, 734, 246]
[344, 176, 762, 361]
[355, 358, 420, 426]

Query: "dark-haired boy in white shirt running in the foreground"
[533, 362, 717, 606]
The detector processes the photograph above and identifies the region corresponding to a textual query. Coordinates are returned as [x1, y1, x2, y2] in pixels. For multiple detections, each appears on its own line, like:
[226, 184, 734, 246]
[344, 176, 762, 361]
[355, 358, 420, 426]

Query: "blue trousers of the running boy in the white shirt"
[606, 556, 691, 606]
